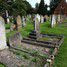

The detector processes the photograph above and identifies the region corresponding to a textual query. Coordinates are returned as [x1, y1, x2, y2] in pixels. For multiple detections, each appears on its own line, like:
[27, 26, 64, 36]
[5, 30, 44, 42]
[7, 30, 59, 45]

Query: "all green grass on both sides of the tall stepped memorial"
[4, 21, 67, 67]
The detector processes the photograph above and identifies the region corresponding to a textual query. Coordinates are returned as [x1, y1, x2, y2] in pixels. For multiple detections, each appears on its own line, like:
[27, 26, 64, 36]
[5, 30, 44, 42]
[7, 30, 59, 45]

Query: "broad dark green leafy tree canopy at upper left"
[0, 0, 32, 16]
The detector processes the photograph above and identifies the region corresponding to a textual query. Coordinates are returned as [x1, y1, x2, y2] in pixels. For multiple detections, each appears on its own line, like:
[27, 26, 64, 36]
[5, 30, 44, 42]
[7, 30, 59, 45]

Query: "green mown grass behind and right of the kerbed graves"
[41, 22, 67, 67]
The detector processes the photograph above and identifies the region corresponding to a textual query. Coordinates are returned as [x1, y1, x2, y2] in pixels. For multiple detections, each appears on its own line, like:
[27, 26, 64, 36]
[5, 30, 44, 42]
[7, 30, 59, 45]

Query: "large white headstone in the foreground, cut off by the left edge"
[0, 16, 8, 50]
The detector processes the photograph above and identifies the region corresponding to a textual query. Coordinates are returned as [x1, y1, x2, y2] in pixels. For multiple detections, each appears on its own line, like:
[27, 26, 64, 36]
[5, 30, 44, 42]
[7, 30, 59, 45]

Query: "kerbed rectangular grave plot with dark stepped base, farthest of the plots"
[22, 31, 64, 47]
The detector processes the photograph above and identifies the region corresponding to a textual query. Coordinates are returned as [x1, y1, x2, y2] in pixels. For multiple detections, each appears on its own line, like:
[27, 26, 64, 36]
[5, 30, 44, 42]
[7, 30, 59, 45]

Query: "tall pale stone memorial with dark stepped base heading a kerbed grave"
[29, 14, 41, 40]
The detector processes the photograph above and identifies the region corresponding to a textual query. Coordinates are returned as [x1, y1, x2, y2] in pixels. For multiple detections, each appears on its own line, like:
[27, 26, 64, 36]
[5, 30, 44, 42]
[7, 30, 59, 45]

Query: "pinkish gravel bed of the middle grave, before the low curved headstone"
[10, 42, 54, 58]
